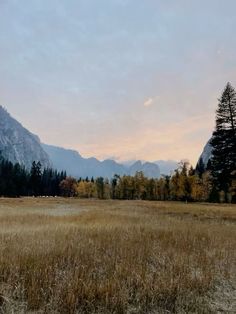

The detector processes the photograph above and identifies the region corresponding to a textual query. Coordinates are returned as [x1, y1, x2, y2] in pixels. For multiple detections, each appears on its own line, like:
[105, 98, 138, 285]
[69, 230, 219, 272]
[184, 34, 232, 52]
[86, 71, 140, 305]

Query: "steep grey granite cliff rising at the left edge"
[0, 106, 51, 169]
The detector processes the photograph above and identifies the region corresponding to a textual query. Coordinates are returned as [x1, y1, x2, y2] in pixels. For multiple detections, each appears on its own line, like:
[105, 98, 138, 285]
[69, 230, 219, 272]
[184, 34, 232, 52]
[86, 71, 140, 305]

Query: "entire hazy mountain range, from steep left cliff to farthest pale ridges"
[0, 106, 178, 178]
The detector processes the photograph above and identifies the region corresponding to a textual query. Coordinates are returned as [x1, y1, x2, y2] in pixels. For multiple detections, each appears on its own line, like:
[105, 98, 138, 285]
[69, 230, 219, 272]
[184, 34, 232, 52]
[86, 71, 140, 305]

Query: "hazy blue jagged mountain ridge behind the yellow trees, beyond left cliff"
[42, 144, 160, 179]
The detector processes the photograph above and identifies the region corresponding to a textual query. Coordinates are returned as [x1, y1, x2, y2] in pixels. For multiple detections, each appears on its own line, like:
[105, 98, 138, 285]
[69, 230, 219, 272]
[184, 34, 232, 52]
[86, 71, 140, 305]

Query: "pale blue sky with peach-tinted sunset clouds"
[0, 0, 236, 164]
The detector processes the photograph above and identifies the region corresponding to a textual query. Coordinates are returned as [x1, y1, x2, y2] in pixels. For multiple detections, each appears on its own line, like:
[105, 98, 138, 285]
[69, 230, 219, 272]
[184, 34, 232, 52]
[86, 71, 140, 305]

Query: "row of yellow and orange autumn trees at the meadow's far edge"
[60, 162, 218, 201]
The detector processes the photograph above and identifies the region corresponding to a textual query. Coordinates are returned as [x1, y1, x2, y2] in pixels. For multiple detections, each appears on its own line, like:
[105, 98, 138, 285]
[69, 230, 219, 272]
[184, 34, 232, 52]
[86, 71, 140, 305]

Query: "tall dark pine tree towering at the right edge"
[211, 83, 236, 199]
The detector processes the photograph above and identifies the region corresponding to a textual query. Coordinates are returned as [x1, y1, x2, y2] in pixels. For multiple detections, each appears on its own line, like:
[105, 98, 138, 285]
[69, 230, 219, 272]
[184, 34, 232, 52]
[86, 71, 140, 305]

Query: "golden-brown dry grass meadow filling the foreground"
[0, 198, 236, 314]
